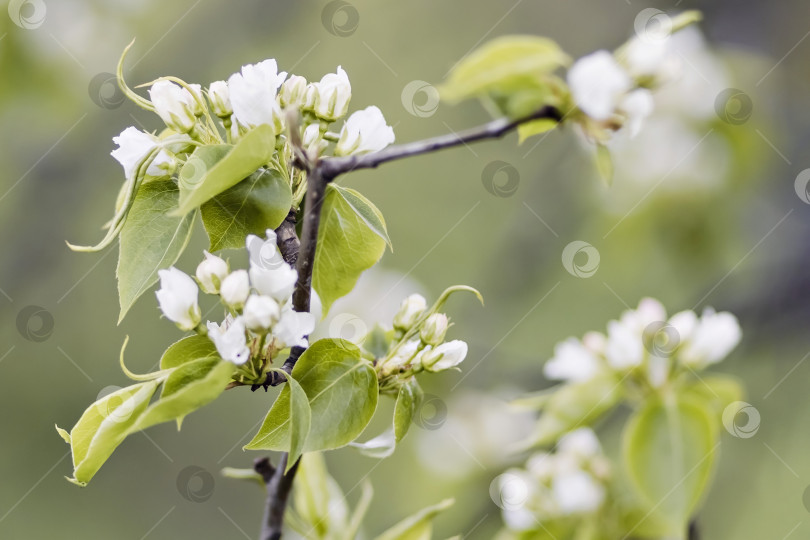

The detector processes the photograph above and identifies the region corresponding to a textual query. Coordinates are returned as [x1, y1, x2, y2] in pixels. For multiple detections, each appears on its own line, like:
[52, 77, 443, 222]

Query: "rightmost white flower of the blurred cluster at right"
[679, 308, 742, 367]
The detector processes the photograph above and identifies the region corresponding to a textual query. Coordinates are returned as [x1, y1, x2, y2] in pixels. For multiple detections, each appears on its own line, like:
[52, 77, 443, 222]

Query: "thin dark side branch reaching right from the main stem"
[317, 106, 562, 182]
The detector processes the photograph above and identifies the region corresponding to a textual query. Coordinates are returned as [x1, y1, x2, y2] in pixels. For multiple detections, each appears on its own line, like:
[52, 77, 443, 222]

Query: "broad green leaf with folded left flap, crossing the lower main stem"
[245, 339, 379, 452]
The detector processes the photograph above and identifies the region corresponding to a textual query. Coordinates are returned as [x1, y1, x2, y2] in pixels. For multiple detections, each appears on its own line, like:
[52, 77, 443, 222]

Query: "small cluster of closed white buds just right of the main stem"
[379, 294, 467, 373]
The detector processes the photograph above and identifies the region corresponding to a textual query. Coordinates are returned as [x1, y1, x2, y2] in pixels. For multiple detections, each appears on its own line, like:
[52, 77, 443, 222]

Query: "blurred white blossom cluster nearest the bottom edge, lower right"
[492, 428, 610, 531]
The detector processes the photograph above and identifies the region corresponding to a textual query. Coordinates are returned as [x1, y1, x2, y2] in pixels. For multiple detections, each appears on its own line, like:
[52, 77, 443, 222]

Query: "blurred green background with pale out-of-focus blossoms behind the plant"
[0, 0, 810, 539]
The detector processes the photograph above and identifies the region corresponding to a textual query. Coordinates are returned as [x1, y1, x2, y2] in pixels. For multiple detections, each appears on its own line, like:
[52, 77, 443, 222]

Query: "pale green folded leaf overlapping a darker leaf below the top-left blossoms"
[175, 124, 276, 215]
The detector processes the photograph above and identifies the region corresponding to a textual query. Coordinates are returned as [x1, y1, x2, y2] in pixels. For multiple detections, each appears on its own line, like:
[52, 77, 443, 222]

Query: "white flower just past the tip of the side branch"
[568, 51, 632, 120]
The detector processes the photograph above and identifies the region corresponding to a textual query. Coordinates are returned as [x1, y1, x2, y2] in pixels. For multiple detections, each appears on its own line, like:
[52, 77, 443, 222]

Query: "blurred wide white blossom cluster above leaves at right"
[543, 298, 742, 388]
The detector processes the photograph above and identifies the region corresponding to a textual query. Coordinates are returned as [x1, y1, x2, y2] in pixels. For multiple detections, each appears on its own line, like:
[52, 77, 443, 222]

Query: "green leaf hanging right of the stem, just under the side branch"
[312, 184, 391, 315]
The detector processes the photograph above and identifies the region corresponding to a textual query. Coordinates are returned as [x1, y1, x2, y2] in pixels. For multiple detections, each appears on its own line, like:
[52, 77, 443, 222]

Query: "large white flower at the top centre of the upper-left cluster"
[228, 59, 287, 134]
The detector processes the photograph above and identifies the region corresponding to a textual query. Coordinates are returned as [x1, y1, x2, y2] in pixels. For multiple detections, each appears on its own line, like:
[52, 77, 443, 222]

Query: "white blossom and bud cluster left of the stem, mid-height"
[157, 230, 320, 365]
